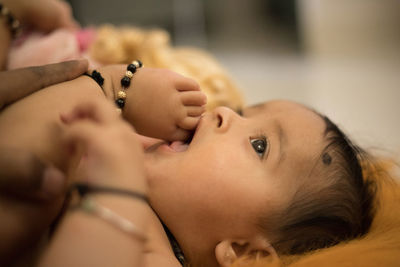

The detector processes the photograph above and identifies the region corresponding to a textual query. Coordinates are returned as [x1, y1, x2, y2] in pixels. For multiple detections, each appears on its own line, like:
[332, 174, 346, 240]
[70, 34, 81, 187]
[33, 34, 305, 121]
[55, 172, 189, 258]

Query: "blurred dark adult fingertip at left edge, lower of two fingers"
[0, 147, 66, 199]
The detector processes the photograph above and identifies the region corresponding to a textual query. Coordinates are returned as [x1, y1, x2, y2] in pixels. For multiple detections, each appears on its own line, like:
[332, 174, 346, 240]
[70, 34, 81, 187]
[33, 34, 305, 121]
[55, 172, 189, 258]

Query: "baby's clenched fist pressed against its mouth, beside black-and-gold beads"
[123, 68, 207, 141]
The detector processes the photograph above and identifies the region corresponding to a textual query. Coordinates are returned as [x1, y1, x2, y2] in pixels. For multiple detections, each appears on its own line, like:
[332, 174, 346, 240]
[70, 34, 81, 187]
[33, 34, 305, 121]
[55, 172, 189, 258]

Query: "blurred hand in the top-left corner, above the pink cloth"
[2, 0, 79, 32]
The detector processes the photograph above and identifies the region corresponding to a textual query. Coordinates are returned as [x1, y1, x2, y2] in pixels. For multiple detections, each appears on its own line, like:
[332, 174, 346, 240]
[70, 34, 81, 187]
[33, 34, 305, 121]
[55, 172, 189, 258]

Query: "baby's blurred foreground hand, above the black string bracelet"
[61, 100, 147, 192]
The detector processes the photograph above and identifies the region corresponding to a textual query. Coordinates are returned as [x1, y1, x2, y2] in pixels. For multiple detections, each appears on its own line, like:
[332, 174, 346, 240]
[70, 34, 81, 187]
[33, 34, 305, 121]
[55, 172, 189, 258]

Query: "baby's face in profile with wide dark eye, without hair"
[146, 101, 325, 249]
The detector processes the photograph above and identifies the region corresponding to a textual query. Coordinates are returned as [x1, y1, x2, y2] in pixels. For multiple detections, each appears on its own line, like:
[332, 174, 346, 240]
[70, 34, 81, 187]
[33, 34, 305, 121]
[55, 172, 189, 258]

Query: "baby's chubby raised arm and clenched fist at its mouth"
[0, 62, 206, 171]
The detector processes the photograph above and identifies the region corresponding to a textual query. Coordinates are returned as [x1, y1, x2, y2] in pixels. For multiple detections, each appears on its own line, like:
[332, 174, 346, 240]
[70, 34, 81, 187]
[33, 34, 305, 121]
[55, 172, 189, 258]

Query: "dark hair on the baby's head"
[260, 115, 375, 255]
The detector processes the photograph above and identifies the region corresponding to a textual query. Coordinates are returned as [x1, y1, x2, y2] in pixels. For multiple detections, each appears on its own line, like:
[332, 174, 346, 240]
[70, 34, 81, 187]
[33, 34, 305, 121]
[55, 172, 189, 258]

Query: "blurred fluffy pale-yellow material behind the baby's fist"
[89, 25, 244, 110]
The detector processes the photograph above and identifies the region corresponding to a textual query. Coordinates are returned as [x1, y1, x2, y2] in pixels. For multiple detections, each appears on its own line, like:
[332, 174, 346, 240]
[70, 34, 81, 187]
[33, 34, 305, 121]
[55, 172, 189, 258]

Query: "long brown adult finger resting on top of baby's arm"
[0, 59, 88, 109]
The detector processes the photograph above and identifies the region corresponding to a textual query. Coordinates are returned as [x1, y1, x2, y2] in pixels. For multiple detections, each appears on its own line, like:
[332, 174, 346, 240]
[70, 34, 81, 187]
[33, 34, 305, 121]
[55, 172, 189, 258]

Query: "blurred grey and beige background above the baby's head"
[69, 0, 400, 156]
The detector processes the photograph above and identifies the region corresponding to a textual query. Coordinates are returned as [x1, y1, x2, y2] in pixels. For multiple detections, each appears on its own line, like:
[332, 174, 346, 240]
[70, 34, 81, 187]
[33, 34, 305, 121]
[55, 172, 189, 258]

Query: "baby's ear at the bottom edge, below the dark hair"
[215, 236, 278, 267]
